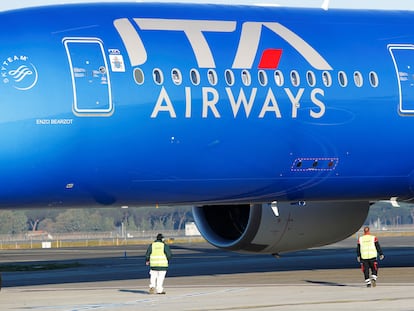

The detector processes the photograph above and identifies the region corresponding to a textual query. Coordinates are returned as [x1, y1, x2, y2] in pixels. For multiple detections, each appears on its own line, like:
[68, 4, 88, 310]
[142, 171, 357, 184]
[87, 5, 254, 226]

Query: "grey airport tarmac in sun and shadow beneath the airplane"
[0, 237, 414, 311]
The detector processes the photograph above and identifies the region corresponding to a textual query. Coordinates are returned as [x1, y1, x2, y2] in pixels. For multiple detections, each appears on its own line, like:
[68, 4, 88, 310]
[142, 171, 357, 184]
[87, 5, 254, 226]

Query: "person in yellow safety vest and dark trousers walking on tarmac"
[357, 227, 384, 287]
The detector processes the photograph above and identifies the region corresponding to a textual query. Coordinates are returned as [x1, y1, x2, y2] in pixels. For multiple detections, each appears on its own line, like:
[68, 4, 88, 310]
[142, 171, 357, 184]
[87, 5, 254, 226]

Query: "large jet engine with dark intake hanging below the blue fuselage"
[193, 201, 369, 254]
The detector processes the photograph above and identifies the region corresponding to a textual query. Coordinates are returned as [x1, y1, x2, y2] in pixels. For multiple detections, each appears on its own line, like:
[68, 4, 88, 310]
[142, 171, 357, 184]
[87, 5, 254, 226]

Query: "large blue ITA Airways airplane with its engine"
[0, 3, 414, 254]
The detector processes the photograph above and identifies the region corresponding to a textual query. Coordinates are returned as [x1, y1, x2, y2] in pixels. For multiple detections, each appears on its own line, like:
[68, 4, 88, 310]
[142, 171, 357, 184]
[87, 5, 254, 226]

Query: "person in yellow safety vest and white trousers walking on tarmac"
[145, 233, 172, 294]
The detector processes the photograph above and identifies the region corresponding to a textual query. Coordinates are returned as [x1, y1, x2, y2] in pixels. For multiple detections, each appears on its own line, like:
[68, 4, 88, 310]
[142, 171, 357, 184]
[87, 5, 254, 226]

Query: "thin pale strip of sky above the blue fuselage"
[0, 0, 414, 10]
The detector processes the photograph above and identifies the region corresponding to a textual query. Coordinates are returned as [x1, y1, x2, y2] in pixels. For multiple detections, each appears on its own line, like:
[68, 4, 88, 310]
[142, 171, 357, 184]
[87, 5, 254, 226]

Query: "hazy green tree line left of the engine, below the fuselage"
[0, 206, 193, 234]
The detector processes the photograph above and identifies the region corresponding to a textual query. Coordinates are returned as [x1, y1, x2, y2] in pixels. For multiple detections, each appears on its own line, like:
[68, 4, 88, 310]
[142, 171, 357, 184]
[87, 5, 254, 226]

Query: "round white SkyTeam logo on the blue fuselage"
[1, 55, 38, 91]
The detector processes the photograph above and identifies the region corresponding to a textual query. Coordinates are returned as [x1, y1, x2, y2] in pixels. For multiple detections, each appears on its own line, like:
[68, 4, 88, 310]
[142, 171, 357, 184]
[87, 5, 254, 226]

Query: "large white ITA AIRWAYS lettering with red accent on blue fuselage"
[114, 18, 332, 119]
